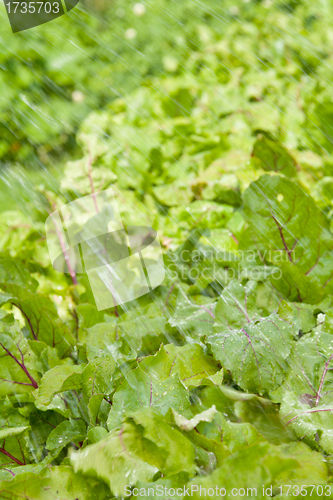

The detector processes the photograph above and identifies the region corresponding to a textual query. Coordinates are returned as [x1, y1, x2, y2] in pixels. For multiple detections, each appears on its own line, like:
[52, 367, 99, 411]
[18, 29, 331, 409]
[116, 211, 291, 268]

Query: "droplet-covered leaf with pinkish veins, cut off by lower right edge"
[272, 333, 333, 453]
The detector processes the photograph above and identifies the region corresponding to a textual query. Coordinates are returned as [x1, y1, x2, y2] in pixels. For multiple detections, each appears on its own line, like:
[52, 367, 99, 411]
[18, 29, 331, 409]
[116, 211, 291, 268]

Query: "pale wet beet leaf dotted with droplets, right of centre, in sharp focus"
[208, 282, 298, 394]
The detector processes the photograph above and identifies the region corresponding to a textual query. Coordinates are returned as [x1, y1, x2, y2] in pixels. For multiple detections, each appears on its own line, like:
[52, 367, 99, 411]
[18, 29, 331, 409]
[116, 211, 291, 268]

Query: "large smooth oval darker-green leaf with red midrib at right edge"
[244, 175, 333, 303]
